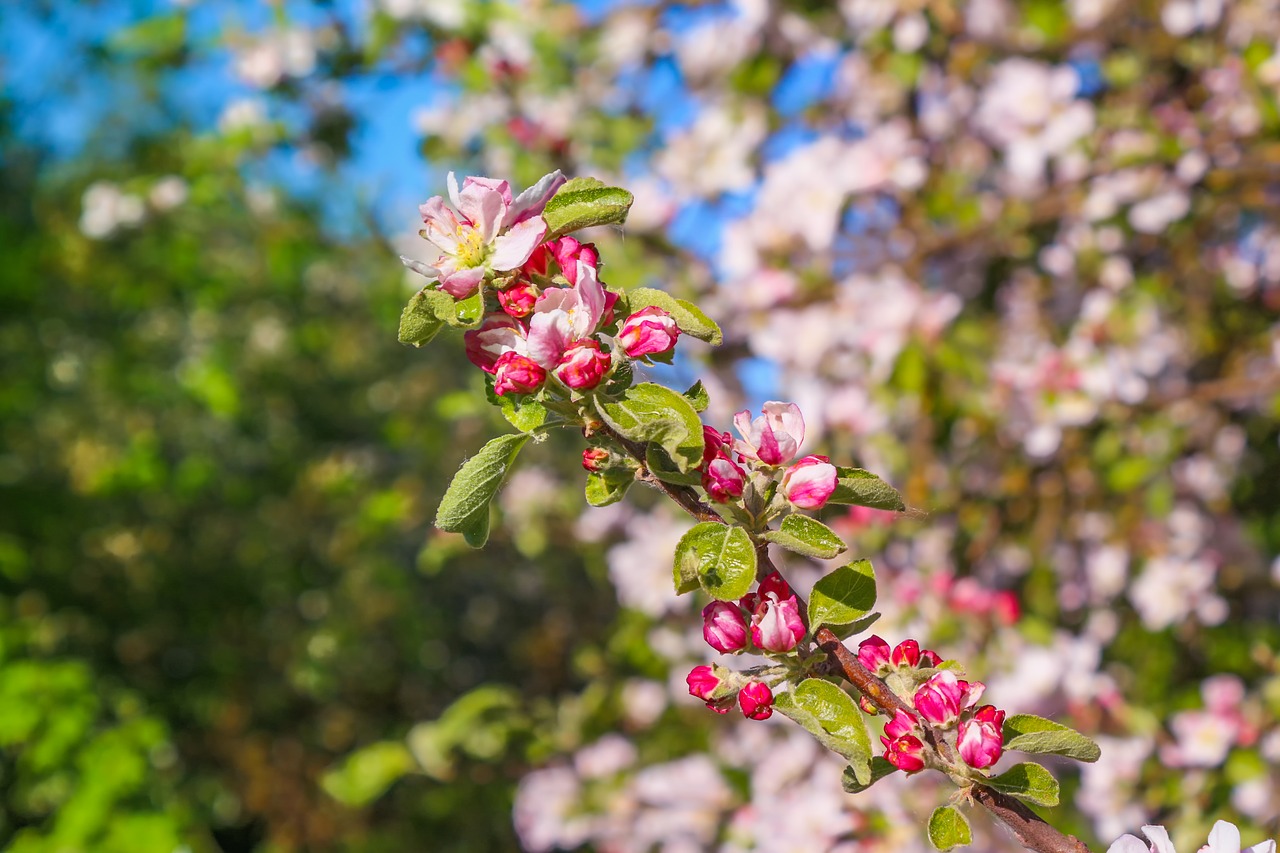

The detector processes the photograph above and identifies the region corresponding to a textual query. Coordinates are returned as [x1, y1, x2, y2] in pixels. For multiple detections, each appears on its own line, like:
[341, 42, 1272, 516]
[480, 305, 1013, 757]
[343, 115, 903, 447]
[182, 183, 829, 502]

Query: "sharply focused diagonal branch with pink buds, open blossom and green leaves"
[399, 173, 1098, 853]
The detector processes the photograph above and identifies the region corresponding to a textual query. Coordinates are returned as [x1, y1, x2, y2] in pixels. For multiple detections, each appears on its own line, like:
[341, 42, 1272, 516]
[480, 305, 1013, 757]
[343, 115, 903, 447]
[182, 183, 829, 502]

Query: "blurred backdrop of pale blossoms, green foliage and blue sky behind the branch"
[0, 0, 1280, 853]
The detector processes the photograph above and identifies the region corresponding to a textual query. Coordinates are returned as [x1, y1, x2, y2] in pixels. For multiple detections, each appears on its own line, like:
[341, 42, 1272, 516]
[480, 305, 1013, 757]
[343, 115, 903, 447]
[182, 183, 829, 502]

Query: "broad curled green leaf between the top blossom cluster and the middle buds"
[596, 382, 703, 474]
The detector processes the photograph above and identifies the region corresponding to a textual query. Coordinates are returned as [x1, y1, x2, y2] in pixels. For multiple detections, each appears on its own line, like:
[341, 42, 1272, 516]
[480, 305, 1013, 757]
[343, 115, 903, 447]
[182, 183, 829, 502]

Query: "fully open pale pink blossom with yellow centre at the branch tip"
[401, 170, 564, 298]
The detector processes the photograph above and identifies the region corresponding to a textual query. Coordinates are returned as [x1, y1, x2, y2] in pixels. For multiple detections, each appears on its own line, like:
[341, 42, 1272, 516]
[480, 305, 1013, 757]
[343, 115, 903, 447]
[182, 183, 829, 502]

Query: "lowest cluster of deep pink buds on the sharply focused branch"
[858, 634, 1005, 774]
